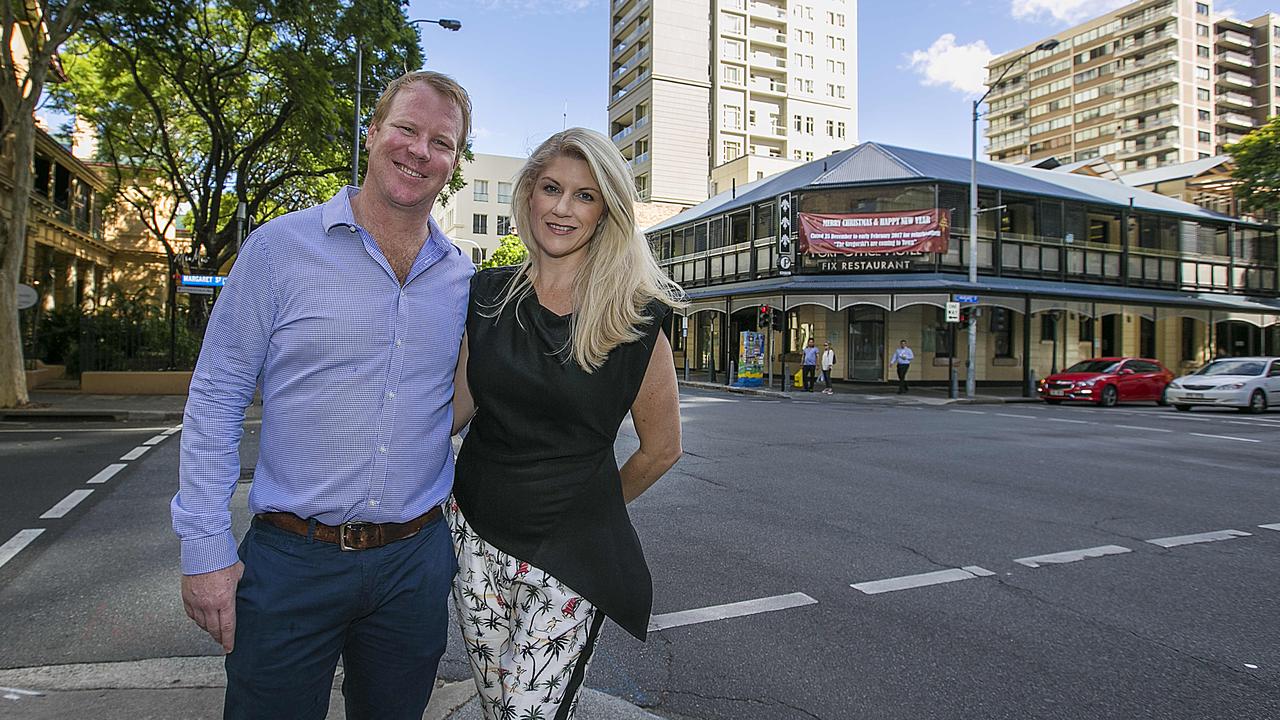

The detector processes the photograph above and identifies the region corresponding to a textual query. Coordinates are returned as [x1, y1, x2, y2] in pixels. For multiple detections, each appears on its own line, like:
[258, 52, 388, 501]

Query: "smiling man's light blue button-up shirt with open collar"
[172, 187, 475, 575]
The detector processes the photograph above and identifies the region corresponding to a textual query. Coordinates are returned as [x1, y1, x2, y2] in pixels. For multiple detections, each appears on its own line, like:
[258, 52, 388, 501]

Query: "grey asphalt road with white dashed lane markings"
[0, 392, 1280, 720]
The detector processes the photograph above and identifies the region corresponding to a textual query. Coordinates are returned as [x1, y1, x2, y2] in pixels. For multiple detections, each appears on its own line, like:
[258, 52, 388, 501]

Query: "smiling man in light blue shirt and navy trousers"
[172, 72, 474, 720]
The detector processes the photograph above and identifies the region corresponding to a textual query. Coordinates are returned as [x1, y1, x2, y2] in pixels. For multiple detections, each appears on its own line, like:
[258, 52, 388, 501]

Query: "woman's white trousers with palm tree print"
[444, 498, 604, 720]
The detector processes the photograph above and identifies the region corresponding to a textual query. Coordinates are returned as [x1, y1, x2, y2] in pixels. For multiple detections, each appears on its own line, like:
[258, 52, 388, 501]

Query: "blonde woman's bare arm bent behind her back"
[622, 332, 682, 502]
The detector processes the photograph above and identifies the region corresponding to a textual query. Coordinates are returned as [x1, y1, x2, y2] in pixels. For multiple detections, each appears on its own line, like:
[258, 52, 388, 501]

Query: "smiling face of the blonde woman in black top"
[529, 155, 604, 259]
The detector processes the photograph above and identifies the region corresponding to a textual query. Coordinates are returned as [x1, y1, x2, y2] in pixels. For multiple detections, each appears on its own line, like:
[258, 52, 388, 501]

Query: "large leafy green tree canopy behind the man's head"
[59, 0, 421, 315]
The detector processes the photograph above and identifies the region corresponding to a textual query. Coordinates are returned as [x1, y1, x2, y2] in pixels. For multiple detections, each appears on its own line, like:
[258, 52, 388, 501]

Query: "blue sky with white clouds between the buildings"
[408, 0, 1280, 156]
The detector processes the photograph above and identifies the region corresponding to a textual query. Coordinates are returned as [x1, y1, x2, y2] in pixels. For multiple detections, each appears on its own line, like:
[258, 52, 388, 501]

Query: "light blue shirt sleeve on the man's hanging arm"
[170, 233, 276, 575]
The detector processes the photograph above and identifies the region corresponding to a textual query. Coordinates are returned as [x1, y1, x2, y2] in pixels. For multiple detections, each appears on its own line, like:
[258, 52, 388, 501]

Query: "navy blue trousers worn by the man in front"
[223, 519, 457, 720]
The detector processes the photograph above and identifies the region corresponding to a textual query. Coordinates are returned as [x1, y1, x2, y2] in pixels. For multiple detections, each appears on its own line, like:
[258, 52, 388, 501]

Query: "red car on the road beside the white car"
[1039, 357, 1174, 407]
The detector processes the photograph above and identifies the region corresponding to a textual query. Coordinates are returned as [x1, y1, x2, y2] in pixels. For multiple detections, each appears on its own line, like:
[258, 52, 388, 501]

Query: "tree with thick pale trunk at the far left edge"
[0, 0, 83, 407]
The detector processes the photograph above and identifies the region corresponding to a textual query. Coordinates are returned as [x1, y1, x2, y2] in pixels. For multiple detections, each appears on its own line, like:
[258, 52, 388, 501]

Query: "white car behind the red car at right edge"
[1165, 357, 1280, 413]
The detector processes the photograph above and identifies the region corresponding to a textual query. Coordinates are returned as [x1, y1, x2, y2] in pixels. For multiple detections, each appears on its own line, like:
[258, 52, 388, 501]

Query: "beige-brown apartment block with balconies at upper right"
[986, 0, 1280, 173]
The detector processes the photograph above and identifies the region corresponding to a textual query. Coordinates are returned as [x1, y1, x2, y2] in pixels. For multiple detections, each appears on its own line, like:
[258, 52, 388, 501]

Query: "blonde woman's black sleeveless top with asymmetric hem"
[453, 268, 669, 639]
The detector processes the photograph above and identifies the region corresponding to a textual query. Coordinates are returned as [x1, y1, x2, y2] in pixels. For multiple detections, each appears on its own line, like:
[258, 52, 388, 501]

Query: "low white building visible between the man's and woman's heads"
[431, 152, 525, 265]
